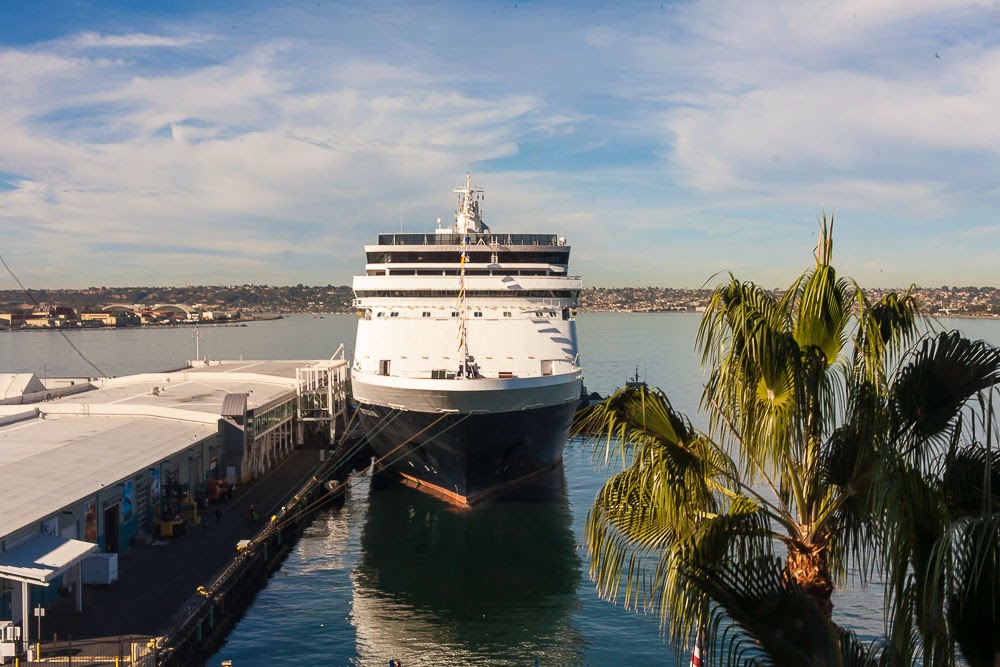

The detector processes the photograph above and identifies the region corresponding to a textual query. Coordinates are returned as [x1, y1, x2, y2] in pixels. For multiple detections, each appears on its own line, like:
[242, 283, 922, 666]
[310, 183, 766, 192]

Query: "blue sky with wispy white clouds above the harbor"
[0, 0, 1000, 288]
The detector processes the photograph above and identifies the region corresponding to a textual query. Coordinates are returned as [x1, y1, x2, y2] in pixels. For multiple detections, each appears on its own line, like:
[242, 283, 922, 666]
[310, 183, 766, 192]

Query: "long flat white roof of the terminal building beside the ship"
[0, 360, 344, 537]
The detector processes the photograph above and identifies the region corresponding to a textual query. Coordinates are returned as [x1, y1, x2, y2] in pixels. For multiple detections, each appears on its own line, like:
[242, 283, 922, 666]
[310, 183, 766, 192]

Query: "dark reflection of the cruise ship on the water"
[351, 464, 584, 667]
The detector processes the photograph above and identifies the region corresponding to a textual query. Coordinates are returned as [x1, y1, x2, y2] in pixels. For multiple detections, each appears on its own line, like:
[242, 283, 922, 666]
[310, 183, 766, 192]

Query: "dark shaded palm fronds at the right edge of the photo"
[878, 333, 1000, 667]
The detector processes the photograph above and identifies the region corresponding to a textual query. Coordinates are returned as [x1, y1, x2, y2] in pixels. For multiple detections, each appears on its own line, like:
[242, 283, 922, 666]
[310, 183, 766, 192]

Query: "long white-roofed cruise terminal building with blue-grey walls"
[0, 359, 347, 661]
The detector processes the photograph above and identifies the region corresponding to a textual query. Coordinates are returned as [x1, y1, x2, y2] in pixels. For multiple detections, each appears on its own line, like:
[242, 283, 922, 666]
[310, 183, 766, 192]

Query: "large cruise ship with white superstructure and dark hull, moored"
[351, 175, 582, 506]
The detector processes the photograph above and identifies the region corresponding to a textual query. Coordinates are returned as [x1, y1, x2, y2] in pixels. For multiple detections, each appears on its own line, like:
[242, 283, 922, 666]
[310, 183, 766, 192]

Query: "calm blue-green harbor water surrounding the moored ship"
[0, 313, 1000, 667]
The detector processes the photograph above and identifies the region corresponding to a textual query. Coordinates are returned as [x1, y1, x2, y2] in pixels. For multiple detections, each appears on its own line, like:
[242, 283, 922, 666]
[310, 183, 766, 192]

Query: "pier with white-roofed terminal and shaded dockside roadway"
[0, 359, 356, 665]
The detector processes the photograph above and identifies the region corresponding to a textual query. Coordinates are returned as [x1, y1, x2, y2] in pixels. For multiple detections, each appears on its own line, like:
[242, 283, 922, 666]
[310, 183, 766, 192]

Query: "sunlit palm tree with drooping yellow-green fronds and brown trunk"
[576, 216, 995, 664]
